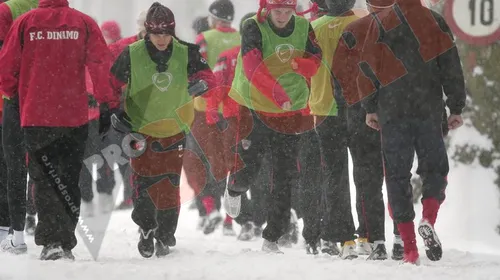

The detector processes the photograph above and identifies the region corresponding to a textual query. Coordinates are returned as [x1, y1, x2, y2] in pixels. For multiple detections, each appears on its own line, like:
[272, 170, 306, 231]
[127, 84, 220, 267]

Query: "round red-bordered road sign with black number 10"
[444, 0, 500, 46]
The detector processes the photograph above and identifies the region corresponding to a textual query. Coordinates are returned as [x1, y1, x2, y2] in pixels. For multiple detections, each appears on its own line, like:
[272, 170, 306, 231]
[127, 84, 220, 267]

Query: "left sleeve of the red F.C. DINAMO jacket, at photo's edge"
[0, 19, 24, 98]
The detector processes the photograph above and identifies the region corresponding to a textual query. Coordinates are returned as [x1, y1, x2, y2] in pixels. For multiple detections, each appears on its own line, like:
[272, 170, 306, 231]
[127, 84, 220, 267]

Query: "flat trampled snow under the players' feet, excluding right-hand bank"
[0, 206, 500, 280]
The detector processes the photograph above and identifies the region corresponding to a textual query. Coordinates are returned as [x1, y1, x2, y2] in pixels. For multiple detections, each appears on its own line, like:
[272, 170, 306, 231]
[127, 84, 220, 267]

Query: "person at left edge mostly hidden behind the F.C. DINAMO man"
[0, 0, 38, 254]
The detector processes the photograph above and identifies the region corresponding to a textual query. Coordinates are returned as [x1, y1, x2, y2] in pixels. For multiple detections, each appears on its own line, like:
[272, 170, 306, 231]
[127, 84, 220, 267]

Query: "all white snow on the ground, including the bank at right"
[0, 129, 500, 280]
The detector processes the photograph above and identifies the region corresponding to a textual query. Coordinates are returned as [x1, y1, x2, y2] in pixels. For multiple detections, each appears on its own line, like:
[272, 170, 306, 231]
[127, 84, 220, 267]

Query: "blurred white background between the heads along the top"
[69, 0, 365, 41]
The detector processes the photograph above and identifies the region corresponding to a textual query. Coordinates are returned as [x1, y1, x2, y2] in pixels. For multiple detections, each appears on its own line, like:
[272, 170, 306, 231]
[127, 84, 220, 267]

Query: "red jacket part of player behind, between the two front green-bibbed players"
[206, 46, 241, 124]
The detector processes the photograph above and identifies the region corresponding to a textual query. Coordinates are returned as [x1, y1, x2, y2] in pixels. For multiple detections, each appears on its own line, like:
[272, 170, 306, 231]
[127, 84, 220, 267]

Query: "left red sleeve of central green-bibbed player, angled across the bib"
[243, 49, 290, 108]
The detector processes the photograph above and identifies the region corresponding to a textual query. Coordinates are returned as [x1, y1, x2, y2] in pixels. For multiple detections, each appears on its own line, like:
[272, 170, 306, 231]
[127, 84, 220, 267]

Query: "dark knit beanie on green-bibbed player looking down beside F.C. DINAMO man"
[144, 2, 175, 36]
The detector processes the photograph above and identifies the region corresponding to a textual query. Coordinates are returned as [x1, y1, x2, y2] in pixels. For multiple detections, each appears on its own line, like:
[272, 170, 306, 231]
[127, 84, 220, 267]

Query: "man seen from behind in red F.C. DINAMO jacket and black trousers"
[0, 0, 118, 260]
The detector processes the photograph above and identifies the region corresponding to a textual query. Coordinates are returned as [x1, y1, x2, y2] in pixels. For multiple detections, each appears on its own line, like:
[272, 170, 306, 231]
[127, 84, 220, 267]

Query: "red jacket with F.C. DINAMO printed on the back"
[0, 0, 119, 127]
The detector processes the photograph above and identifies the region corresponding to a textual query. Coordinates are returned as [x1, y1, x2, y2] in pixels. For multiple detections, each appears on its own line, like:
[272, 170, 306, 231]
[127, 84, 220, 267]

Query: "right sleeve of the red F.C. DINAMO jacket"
[86, 17, 120, 108]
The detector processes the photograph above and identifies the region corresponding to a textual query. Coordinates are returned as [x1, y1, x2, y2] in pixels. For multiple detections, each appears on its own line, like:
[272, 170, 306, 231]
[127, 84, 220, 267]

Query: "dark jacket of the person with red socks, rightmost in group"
[334, 0, 466, 122]
